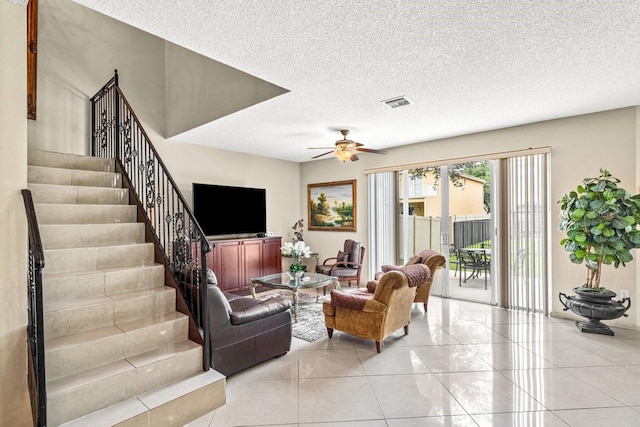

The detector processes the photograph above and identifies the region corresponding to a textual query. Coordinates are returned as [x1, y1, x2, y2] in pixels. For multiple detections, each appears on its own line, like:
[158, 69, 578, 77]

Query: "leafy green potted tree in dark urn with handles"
[558, 169, 640, 335]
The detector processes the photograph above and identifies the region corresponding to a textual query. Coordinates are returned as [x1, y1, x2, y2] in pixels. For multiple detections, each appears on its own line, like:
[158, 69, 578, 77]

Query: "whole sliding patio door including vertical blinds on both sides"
[369, 147, 550, 313]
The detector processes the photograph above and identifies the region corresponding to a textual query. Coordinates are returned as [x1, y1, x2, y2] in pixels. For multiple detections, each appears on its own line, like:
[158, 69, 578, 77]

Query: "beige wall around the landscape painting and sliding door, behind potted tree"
[300, 107, 640, 327]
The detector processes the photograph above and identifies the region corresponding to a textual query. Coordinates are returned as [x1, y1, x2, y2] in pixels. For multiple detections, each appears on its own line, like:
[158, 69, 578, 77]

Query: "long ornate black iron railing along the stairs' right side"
[91, 70, 211, 370]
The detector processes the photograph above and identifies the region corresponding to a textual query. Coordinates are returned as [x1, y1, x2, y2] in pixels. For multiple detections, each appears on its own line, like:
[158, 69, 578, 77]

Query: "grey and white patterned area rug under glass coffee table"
[260, 291, 329, 342]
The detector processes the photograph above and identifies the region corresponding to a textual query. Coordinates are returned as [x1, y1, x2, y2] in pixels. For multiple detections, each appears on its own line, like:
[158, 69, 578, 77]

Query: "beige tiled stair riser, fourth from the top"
[35, 203, 136, 225]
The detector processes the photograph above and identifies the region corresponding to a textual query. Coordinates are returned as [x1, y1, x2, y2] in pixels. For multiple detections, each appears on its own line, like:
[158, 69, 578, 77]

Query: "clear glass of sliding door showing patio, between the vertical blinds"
[398, 161, 496, 303]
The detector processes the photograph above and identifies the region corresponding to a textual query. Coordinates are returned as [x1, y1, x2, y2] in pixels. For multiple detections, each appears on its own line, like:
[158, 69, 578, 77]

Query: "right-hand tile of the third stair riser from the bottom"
[124, 316, 189, 357]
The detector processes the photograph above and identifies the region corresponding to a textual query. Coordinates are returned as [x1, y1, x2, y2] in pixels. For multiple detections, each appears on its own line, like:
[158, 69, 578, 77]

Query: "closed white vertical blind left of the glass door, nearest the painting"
[368, 172, 398, 277]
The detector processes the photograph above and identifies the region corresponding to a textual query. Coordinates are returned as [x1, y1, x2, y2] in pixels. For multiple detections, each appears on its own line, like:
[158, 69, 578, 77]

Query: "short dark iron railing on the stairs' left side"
[22, 190, 47, 427]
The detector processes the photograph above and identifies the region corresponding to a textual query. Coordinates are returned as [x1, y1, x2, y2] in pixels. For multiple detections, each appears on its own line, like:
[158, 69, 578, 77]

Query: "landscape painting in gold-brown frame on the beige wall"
[307, 179, 356, 231]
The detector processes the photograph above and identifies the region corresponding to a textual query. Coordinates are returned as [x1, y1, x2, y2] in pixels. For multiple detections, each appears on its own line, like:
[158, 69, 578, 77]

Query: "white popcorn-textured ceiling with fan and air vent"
[76, 0, 640, 162]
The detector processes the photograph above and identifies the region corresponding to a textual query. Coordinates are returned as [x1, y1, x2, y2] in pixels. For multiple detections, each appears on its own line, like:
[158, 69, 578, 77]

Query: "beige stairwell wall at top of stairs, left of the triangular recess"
[29, 0, 165, 154]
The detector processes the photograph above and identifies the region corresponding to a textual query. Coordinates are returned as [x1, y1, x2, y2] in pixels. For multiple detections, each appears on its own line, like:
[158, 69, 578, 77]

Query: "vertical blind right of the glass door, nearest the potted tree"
[501, 154, 549, 314]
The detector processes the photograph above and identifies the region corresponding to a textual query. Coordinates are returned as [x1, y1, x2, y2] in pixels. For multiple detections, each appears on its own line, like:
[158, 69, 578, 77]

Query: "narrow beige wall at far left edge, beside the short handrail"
[0, 0, 31, 426]
